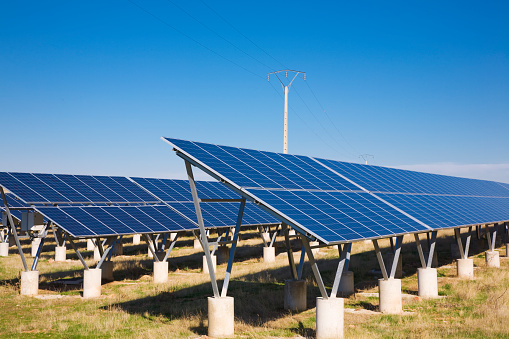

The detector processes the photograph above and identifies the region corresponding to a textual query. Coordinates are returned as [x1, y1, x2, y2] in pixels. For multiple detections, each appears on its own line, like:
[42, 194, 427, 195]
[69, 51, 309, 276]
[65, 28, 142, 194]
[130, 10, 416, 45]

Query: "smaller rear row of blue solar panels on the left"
[0, 172, 277, 237]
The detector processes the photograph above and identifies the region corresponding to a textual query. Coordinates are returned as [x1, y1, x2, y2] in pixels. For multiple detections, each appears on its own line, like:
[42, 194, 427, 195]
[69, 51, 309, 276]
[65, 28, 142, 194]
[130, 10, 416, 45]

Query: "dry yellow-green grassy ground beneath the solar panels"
[0, 232, 509, 338]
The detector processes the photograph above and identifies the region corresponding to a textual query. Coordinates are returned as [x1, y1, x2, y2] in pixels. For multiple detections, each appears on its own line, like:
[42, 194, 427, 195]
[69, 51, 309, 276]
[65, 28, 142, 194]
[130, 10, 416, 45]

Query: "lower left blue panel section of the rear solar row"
[37, 205, 197, 237]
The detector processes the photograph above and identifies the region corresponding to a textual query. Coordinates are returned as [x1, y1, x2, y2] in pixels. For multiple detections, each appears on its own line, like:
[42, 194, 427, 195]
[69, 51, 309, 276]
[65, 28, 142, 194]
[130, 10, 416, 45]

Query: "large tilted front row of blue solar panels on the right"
[163, 138, 509, 243]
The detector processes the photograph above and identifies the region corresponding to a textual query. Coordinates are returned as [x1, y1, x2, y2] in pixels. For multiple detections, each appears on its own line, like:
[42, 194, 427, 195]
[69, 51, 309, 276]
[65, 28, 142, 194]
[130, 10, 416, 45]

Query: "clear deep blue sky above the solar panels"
[0, 0, 509, 183]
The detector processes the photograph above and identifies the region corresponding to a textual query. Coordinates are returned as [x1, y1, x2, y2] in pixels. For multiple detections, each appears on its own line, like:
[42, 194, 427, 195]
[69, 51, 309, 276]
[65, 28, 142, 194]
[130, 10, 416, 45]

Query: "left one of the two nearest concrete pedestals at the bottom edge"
[207, 297, 235, 338]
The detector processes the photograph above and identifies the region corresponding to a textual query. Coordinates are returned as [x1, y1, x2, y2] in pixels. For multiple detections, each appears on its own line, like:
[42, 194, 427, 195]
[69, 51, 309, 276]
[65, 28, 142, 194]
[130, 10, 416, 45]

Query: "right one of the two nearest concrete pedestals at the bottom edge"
[316, 297, 344, 339]
